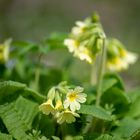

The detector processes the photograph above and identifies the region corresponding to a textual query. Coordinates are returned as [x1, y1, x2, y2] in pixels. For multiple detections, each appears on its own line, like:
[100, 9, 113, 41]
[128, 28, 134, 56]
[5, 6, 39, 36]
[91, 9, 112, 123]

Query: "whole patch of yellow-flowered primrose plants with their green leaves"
[0, 13, 140, 140]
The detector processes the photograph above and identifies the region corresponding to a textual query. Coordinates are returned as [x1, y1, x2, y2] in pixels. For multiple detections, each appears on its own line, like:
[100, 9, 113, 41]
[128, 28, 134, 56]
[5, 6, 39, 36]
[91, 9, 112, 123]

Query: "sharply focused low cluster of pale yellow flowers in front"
[39, 83, 87, 124]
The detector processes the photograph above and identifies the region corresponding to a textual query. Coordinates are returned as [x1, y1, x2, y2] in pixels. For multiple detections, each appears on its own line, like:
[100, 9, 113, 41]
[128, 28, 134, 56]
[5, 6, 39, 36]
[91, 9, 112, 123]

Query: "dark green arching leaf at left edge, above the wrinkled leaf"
[0, 81, 45, 104]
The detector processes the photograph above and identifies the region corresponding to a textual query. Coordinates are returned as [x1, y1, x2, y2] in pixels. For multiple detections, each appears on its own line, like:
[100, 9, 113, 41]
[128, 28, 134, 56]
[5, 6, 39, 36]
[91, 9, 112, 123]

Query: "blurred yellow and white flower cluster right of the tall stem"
[106, 39, 138, 71]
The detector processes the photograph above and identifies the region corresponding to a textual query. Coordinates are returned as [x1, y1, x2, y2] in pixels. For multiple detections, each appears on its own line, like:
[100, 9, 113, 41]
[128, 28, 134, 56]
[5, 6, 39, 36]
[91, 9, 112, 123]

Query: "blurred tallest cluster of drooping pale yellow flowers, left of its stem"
[64, 15, 105, 63]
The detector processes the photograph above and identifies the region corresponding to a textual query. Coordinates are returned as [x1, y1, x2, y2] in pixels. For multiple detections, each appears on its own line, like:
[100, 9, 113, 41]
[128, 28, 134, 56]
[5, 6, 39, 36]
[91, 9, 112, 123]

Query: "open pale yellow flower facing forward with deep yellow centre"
[64, 87, 87, 112]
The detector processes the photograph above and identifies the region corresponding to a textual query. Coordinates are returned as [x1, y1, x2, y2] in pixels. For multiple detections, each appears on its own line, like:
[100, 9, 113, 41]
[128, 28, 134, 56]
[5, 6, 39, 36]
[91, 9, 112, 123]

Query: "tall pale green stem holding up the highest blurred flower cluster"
[96, 39, 106, 105]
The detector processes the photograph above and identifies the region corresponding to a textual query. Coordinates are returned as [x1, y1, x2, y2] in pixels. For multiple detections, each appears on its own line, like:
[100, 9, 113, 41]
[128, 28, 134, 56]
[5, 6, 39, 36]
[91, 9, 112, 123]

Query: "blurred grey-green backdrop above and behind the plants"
[0, 0, 140, 87]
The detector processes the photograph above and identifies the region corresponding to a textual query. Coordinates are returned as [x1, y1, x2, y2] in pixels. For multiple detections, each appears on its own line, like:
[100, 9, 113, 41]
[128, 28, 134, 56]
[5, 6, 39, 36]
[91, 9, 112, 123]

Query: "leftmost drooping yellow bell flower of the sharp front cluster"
[39, 99, 55, 115]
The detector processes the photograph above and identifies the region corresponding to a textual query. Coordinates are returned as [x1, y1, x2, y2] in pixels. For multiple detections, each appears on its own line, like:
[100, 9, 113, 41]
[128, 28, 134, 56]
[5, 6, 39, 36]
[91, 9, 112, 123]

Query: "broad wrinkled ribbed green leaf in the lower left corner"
[0, 96, 38, 140]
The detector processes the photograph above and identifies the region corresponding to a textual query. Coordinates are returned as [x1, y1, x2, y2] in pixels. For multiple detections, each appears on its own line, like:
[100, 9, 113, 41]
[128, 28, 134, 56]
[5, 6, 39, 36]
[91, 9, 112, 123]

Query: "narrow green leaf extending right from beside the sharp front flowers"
[78, 105, 112, 121]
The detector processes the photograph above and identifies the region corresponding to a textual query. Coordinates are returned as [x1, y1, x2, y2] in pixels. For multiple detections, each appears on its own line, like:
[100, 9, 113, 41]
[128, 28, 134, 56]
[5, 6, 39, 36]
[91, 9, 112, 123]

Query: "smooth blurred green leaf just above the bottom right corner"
[113, 117, 140, 138]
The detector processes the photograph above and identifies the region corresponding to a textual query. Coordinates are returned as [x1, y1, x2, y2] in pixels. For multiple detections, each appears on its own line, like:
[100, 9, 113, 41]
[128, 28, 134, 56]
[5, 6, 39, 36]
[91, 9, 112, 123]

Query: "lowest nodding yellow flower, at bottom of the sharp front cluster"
[57, 109, 80, 124]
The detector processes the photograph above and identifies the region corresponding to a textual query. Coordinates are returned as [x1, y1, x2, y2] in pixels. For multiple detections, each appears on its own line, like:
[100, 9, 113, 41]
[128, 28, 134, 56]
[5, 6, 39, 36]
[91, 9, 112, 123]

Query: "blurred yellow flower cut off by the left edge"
[0, 39, 11, 64]
